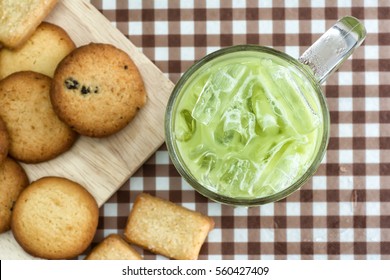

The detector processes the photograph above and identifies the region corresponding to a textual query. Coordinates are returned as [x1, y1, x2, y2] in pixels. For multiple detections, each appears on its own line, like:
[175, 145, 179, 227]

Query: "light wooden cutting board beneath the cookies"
[0, 0, 173, 259]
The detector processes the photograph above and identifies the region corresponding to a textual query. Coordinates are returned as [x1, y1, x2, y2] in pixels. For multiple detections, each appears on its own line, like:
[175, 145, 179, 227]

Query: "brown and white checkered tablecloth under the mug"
[87, 0, 390, 259]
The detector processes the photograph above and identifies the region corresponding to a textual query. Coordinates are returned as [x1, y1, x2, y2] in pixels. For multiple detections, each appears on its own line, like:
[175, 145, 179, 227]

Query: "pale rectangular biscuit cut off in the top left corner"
[0, 0, 57, 48]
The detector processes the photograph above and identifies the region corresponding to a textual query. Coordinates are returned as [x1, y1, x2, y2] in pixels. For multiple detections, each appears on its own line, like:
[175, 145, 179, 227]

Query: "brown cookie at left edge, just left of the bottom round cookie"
[0, 158, 29, 233]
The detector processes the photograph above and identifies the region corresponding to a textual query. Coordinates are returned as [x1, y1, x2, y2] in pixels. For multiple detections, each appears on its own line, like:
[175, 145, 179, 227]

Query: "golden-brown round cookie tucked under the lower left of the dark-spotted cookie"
[0, 71, 77, 163]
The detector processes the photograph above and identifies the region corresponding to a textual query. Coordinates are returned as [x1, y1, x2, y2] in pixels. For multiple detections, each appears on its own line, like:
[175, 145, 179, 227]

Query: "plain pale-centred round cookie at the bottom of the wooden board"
[11, 177, 99, 259]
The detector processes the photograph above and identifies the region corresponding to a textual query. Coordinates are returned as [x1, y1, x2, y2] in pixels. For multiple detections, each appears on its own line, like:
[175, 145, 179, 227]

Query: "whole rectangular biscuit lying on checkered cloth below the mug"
[124, 193, 214, 260]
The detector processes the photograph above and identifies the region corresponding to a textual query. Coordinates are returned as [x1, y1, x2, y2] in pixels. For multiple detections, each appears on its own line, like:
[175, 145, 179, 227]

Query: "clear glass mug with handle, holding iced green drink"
[165, 16, 366, 206]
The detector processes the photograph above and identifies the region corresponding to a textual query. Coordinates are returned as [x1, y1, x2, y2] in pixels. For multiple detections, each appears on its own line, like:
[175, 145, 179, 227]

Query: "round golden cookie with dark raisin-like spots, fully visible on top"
[50, 43, 146, 137]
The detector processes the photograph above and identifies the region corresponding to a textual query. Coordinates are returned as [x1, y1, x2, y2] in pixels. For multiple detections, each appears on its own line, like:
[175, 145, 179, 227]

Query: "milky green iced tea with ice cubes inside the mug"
[170, 47, 324, 199]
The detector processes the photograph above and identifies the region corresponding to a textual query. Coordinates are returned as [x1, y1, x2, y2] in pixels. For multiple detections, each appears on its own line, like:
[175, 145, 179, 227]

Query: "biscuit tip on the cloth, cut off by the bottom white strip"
[85, 234, 142, 260]
